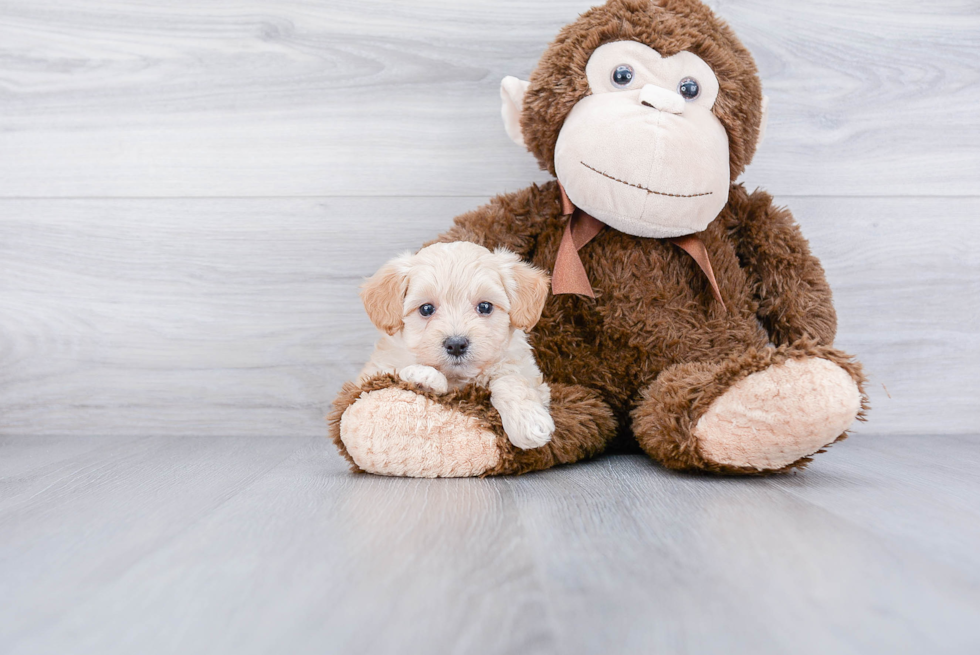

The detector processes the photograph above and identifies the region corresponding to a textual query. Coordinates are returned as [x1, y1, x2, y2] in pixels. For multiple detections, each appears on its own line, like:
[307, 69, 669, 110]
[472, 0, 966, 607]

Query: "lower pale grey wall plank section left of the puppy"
[0, 199, 475, 435]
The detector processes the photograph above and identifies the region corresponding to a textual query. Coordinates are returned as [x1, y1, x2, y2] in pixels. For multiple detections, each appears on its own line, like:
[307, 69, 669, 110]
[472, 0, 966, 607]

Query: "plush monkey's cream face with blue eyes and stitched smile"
[554, 41, 731, 238]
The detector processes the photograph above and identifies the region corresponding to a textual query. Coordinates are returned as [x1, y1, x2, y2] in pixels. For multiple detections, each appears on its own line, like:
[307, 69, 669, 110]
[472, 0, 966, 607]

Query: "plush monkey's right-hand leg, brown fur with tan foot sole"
[632, 342, 866, 474]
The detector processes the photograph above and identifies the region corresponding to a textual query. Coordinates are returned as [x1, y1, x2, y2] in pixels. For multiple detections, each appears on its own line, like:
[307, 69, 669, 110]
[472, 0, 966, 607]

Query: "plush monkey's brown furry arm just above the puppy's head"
[426, 182, 561, 259]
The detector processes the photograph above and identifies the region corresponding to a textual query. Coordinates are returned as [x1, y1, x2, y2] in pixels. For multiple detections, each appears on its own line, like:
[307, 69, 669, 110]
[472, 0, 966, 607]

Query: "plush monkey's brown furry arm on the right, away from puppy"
[729, 186, 837, 345]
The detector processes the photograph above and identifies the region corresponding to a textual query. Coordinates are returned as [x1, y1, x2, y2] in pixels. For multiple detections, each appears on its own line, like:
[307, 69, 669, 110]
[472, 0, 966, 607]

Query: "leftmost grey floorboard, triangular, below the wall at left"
[0, 437, 310, 652]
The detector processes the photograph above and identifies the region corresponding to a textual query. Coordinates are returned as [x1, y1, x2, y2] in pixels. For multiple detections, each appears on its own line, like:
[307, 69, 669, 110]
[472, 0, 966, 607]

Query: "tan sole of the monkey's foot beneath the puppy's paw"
[340, 388, 500, 478]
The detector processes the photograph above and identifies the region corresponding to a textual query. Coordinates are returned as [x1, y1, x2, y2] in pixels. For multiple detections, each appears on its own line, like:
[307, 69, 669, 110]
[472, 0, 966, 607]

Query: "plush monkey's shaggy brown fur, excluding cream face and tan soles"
[330, 0, 867, 474]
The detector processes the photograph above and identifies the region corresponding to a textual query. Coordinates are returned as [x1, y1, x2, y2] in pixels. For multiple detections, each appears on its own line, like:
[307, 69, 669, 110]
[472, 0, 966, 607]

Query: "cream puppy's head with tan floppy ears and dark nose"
[361, 241, 548, 380]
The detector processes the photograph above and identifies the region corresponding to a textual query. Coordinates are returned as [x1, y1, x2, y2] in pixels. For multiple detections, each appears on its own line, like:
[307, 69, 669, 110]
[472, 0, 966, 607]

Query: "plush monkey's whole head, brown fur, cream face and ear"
[500, 0, 768, 238]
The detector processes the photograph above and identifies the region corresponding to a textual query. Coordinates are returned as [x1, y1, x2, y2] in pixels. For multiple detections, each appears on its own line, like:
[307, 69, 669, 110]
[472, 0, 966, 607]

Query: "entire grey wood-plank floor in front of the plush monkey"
[0, 435, 980, 655]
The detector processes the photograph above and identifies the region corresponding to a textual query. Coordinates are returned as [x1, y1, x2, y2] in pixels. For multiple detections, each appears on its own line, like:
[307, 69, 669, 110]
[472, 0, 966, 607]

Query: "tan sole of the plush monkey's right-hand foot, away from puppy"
[694, 358, 861, 471]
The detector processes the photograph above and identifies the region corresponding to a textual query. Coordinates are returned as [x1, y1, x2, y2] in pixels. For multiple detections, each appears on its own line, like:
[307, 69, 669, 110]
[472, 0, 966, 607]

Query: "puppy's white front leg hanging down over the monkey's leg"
[490, 375, 555, 450]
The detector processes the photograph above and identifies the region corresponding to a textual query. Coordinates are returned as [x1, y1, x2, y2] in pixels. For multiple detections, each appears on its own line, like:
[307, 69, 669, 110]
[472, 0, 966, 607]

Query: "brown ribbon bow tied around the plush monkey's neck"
[551, 182, 725, 309]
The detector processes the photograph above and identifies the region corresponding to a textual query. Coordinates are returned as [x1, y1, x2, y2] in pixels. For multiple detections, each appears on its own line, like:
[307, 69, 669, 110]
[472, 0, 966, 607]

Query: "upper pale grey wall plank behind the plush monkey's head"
[0, 0, 980, 197]
